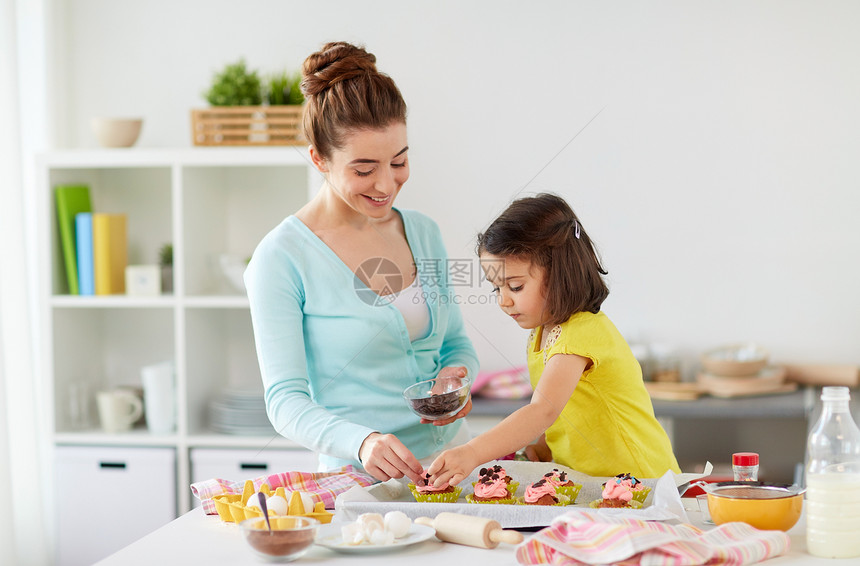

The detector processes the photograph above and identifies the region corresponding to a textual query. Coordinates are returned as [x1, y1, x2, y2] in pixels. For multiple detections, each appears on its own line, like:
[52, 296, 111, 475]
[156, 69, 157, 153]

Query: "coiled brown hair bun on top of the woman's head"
[301, 41, 377, 96]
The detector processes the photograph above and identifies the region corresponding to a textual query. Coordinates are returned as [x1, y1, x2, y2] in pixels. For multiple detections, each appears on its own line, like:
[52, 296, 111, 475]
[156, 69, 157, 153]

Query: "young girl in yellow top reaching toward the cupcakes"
[427, 194, 680, 485]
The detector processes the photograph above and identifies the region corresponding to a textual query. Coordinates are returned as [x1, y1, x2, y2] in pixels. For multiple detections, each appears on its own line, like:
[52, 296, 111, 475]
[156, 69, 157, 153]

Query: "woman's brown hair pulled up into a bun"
[301, 41, 406, 159]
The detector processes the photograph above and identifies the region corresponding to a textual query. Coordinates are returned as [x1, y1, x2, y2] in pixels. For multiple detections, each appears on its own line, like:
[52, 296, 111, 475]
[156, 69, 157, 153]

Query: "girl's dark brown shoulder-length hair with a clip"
[478, 193, 609, 325]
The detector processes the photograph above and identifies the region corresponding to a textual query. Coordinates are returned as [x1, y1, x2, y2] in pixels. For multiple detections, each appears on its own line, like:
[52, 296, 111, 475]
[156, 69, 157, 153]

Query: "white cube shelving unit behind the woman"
[33, 147, 321, 564]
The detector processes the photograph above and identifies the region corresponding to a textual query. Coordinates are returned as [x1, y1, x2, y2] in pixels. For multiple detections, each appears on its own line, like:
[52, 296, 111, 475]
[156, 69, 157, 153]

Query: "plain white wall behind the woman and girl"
[56, 0, 860, 369]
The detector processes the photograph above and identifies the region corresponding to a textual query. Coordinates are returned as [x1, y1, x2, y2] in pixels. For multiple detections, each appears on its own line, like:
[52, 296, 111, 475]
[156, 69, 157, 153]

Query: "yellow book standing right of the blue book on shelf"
[93, 212, 128, 295]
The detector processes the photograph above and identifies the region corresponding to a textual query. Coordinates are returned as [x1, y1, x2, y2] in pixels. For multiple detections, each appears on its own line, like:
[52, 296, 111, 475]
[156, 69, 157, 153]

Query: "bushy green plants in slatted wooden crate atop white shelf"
[191, 59, 305, 145]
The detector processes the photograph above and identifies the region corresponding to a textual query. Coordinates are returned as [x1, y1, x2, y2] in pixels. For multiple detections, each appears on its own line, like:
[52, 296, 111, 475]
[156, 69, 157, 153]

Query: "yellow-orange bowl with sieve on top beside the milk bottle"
[705, 482, 806, 531]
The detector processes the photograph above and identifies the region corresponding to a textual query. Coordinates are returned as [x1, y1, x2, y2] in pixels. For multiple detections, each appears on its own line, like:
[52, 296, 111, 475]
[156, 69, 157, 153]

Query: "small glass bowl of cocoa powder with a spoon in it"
[239, 515, 320, 562]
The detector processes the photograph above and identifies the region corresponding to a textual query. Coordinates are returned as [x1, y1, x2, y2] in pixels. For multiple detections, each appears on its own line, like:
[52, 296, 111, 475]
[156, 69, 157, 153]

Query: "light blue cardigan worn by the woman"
[245, 210, 478, 469]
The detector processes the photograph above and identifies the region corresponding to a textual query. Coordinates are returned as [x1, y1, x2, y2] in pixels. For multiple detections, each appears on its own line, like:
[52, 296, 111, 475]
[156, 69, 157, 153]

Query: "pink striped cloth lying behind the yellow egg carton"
[191, 466, 379, 515]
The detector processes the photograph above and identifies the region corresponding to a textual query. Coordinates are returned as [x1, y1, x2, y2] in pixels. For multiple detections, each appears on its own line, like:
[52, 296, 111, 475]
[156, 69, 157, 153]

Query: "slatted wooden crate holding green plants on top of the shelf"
[191, 105, 307, 145]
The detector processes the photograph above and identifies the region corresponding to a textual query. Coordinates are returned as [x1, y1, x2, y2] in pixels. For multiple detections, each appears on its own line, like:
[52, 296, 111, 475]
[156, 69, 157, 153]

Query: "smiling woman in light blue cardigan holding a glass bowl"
[245, 42, 478, 482]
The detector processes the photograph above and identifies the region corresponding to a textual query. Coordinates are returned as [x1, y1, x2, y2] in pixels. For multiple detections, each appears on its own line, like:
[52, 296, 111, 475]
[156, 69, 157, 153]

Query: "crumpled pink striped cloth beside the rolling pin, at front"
[517, 511, 790, 566]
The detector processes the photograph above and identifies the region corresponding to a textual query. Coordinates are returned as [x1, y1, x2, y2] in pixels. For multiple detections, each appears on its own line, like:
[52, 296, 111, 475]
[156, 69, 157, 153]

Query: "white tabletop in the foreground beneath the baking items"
[97, 508, 858, 566]
